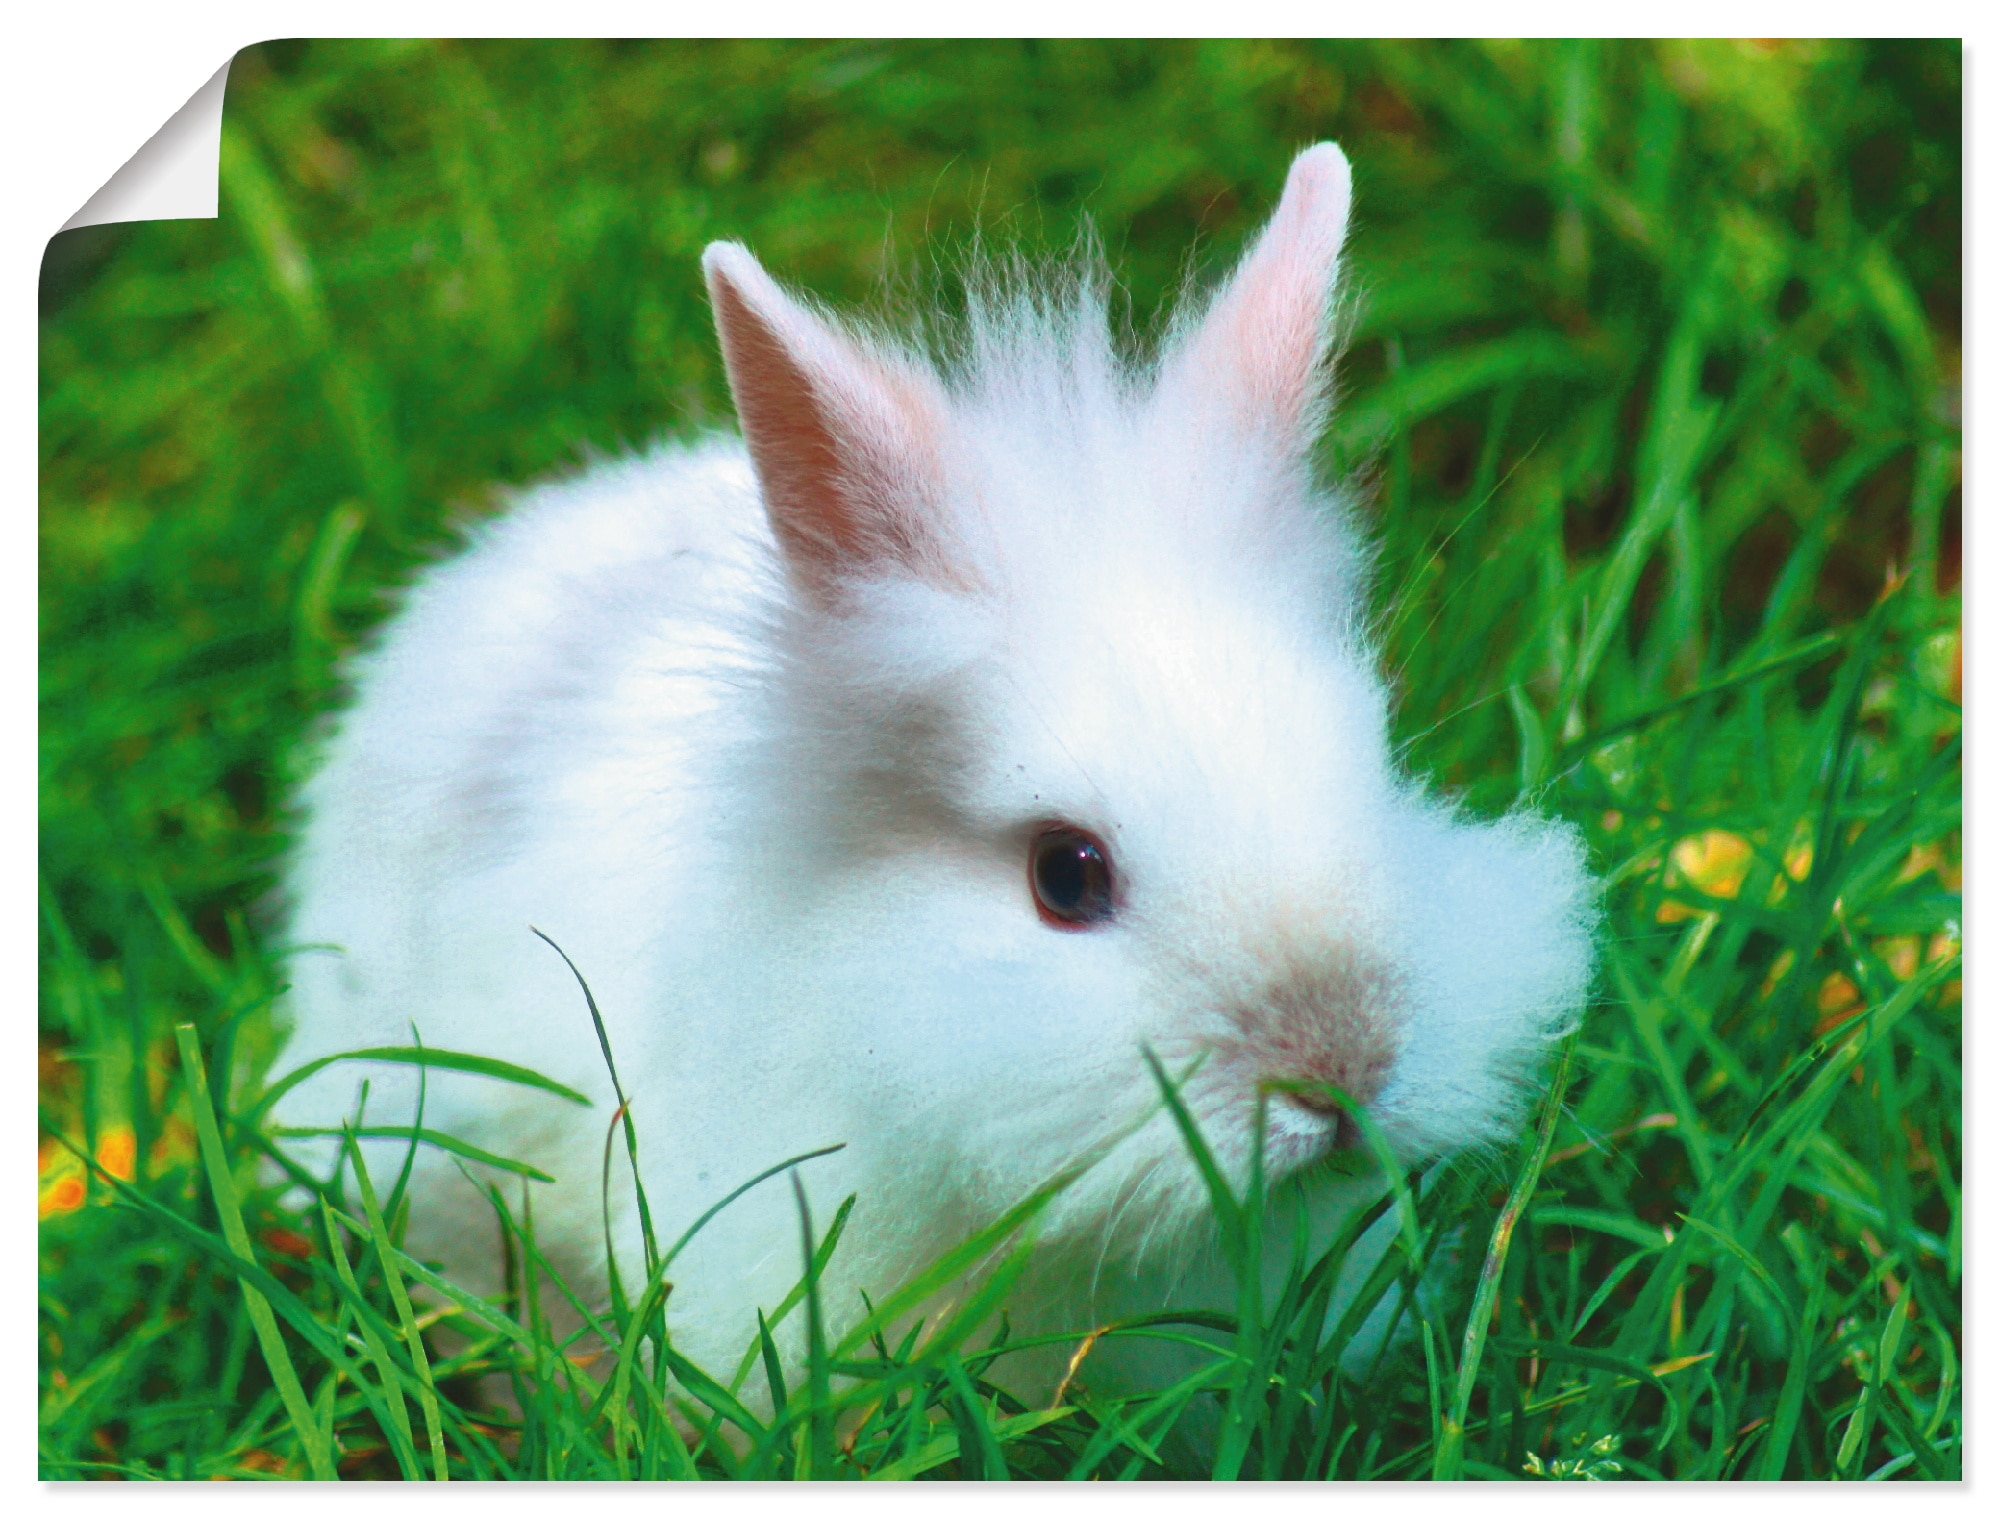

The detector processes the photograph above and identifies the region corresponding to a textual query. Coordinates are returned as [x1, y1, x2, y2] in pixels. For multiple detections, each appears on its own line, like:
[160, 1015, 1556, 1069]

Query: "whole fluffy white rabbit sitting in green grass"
[280, 144, 1594, 1399]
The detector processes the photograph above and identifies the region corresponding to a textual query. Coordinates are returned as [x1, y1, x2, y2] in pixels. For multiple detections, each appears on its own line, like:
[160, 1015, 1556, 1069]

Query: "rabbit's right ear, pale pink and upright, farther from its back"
[1160, 142, 1352, 452]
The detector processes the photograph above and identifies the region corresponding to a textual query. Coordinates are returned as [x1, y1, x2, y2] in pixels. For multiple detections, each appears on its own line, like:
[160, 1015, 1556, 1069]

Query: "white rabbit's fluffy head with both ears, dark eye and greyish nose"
[706, 144, 1592, 1255]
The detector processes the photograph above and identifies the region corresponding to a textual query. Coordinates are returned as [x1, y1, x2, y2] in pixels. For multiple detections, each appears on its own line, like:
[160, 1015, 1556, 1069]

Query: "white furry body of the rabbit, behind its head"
[278, 429, 960, 1357]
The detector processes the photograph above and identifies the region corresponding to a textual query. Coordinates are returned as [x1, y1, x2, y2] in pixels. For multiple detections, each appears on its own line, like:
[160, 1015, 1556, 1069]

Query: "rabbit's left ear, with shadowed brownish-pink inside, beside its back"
[702, 242, 958, 602]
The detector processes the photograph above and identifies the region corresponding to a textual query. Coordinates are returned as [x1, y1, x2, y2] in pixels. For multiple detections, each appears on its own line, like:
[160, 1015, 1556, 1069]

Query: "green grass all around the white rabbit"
[38, 44, 1962, 1479]
